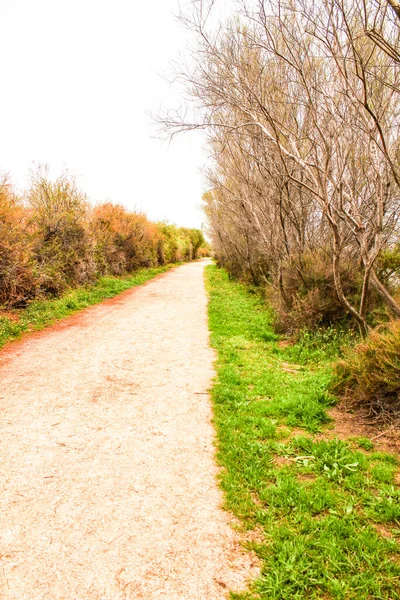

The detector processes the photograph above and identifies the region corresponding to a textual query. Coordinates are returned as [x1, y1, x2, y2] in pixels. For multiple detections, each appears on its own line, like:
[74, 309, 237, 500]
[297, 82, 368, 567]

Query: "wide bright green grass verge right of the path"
[206, 266, 400, 600]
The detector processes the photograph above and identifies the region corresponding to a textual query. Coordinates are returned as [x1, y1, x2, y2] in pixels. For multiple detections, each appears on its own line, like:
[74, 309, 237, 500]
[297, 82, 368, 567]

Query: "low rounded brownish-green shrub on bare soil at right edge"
[334, 320, 400, 420]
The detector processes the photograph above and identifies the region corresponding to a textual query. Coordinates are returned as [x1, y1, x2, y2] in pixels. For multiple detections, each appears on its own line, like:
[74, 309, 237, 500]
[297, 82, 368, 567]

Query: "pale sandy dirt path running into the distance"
[0, 262, 255, 600]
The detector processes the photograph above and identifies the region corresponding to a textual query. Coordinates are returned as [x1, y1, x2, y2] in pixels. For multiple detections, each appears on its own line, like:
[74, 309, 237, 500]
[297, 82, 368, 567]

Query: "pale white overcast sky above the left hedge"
[0, 0, 211, 227]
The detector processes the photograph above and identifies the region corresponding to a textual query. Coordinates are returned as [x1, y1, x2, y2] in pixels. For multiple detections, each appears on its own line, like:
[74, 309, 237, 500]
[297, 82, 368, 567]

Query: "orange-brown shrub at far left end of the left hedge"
[0, 177, 37, 306]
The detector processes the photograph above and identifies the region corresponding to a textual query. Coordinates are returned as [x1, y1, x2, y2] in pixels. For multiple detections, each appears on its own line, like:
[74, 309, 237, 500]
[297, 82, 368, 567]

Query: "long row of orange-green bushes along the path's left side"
[0, 168, 208, 309]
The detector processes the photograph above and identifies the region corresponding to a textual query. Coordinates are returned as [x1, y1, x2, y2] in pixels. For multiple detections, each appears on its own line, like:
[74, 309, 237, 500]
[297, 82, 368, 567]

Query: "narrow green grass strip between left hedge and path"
[0, 265, 176, 348]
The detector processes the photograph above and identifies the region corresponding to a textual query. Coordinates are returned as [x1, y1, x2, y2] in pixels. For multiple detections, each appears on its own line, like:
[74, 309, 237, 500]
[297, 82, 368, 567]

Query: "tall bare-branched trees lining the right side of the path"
[163, 0, 400, 336]
